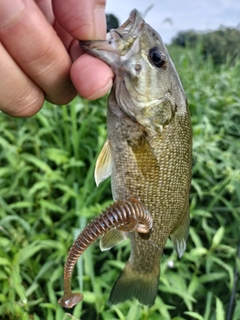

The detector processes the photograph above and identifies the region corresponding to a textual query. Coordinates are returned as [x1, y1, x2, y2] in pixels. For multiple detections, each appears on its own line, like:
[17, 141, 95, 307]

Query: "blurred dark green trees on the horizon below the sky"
[172, 27, 240, 65]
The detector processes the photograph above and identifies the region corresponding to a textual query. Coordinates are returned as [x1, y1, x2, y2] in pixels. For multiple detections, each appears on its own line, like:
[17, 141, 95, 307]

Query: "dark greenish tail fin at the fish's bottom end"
[109, 262, 160, 306]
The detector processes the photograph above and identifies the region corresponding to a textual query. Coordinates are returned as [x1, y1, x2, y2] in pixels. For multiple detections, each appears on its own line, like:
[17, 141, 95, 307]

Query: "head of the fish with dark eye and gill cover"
[80, 9, 186, 132]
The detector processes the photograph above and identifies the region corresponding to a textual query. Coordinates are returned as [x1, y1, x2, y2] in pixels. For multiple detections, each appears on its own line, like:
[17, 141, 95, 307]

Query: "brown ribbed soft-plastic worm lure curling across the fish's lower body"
[58, 197, 153, 308]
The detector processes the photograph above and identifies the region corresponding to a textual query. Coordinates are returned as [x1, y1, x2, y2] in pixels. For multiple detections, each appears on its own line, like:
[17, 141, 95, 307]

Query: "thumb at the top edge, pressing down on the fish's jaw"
[53, 0, 106, 40]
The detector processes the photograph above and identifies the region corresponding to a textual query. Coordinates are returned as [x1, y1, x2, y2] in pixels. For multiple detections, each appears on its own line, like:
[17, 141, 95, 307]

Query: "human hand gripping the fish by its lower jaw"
[0, 0, 113, 117]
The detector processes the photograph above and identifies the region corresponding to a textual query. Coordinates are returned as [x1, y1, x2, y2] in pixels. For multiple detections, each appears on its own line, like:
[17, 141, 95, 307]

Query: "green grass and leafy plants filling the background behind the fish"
[0, 46, 240, 320]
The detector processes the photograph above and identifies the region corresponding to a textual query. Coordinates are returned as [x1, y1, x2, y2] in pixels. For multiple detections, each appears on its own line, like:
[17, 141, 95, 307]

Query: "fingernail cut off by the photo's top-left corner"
[0, 0, 25, 28]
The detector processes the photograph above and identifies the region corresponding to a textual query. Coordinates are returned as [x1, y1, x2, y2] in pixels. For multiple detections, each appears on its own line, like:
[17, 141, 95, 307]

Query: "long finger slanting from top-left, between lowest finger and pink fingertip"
[0, 0, 76, 104]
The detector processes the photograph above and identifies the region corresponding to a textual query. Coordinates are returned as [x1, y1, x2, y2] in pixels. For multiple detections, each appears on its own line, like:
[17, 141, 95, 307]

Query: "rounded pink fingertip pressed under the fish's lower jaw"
[71, 54, 113, 100]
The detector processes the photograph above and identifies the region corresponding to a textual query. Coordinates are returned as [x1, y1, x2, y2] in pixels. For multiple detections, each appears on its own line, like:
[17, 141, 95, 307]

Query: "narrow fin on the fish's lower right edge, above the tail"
[170, 212, 190, 258]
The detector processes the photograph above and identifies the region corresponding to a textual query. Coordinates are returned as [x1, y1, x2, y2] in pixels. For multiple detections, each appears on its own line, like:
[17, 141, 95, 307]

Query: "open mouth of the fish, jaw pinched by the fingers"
[79, 9, 144, 69]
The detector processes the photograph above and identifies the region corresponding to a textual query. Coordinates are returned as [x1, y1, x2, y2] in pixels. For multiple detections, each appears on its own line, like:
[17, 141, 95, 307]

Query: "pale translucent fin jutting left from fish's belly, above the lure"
[94, 140, 112, 186]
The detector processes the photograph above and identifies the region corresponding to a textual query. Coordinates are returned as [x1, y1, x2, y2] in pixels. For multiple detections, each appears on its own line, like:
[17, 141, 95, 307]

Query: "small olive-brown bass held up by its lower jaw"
[80, 9, 192, 306]
